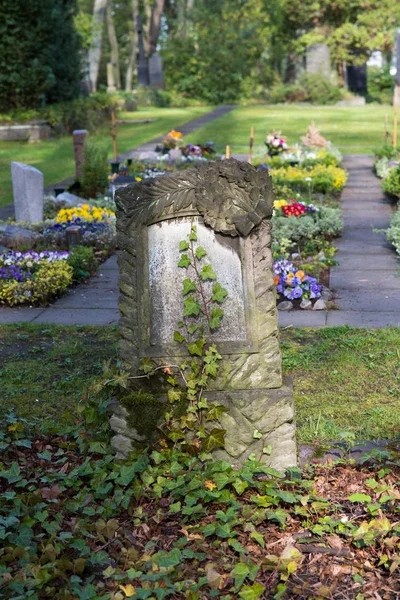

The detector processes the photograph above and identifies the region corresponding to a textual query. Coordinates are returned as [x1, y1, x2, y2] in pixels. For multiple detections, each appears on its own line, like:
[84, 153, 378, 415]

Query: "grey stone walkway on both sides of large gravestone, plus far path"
[0, 152, 400, 328]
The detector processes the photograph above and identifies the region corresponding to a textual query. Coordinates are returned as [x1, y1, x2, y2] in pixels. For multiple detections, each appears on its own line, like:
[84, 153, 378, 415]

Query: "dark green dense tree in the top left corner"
[0, 0, 81, 111]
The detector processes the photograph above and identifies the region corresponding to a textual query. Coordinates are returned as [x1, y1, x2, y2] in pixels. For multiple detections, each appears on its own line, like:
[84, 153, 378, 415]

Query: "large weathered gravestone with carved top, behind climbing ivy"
[111, 159, 297, 469]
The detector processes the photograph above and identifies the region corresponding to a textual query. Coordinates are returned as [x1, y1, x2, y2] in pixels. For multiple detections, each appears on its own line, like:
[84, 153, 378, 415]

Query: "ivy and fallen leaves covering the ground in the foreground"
[0, 402, 400, 600]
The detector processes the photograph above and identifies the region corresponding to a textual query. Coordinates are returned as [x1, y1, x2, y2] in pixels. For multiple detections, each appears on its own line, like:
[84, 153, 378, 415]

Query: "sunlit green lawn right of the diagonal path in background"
[187, 105, 393, 156]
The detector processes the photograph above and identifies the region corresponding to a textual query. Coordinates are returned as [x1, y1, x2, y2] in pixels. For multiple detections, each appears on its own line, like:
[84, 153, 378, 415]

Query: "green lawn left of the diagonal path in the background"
[0, 106, 212, 206]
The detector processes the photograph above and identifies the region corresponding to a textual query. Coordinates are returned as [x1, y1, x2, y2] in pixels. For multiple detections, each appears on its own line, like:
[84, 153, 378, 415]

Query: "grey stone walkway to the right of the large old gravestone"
[279, 154, 400, 328]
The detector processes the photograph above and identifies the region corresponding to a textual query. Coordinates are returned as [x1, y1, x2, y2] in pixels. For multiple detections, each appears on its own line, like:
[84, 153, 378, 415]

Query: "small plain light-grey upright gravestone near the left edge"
[11, 161, 44, 223]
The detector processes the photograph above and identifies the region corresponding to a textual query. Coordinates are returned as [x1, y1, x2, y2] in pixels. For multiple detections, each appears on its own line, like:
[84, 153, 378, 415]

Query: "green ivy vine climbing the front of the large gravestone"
[141, 224, 228, 453]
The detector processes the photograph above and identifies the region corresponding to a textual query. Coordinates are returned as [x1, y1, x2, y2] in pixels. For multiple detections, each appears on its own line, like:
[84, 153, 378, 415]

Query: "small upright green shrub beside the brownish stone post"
[81, 139, 108, 198]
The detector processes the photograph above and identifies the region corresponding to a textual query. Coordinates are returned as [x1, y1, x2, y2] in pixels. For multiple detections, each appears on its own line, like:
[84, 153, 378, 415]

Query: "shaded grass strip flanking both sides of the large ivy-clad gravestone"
[0, 325, 400, 442]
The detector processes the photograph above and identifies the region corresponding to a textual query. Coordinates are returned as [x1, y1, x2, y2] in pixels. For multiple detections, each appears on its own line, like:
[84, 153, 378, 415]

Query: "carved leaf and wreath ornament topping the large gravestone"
[116, 158, 273, 237]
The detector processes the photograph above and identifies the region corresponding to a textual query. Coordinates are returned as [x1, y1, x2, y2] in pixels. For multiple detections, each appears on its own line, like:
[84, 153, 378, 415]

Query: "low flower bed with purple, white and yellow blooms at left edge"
[0, 251, 73, 306]
